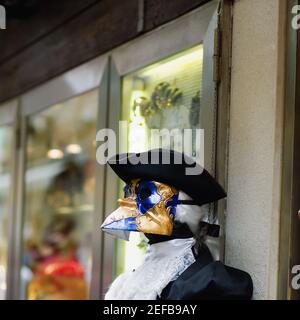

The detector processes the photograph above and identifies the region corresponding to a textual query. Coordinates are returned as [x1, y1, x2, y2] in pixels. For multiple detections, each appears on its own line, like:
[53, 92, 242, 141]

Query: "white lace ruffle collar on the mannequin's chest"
[105, 238, 195, 300]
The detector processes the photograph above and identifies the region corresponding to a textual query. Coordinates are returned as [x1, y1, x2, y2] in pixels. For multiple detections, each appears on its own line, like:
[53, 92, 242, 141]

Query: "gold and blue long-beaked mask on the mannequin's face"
[101, 180, 179, 240]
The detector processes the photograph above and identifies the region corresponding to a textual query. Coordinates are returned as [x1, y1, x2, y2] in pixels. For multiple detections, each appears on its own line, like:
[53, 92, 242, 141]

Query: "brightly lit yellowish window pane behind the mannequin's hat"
[115, 44, 203, 275]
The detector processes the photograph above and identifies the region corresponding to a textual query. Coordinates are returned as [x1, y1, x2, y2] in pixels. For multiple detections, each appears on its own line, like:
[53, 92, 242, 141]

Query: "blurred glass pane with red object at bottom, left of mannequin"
[21, 91, 98, 300]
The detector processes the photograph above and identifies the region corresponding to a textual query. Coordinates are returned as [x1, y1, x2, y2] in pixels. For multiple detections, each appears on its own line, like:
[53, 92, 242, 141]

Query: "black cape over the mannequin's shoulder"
[157, 247, 253, 300]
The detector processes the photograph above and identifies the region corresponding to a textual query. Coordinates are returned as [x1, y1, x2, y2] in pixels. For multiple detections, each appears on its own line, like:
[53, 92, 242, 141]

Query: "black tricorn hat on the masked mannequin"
[108, 149, 226, 205]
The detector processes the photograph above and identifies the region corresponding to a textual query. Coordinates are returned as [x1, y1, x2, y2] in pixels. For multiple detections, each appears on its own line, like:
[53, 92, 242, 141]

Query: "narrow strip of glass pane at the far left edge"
[0, 126, 13, 300]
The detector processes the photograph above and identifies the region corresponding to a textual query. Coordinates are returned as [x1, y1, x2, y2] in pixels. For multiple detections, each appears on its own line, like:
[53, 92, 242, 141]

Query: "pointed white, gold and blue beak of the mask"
[101, 198, 138, 240]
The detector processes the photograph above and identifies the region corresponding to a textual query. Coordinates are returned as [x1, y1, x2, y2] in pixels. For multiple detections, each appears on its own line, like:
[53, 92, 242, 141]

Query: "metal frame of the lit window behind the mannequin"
[102, 1, 224, 297]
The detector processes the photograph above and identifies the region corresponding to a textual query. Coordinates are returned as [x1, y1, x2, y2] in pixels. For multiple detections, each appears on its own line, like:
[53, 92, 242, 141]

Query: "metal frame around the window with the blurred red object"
[9, 54, 108, 299]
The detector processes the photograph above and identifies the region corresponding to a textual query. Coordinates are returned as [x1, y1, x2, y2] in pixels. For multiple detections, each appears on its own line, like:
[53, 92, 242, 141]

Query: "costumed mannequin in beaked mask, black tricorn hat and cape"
[101, 149, 253, 300]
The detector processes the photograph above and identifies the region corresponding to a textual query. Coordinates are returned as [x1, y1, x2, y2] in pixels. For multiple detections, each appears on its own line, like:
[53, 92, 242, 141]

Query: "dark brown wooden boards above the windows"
[0, 0, 209, 102]
